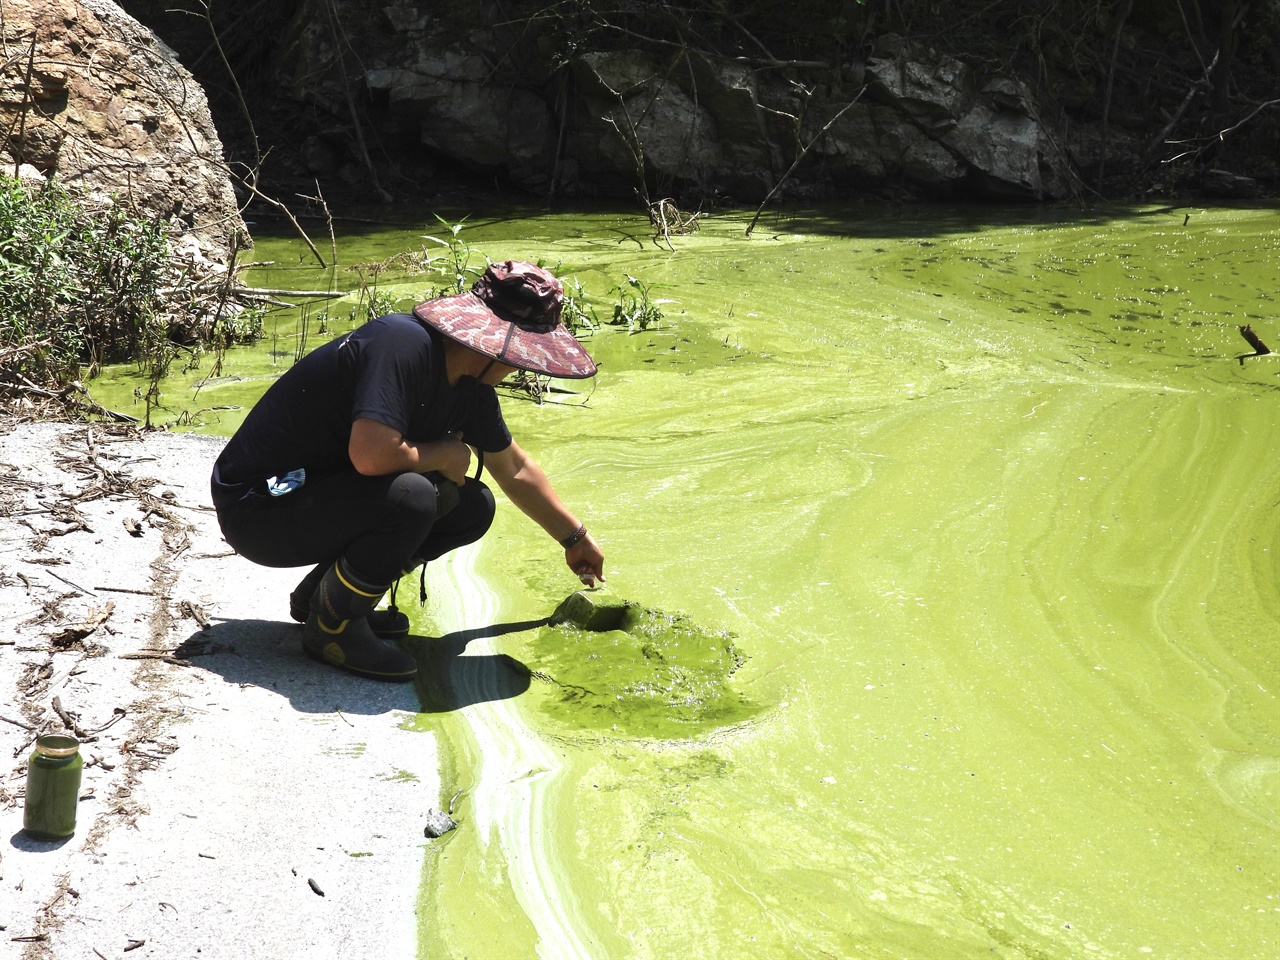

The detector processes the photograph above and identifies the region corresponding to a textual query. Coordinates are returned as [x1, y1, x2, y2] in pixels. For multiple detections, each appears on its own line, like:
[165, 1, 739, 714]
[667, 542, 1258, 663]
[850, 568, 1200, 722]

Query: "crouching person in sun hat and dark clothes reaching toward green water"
[211, 261, 604, 681]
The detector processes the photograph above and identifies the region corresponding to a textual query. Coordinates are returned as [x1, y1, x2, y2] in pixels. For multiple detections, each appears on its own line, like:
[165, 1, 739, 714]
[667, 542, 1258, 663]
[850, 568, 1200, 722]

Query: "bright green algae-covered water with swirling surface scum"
[87, 200, 1280, 959]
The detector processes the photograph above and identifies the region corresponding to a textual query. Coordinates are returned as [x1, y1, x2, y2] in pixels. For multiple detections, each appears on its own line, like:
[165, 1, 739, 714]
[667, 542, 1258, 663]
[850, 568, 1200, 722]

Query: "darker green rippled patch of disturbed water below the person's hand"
[529, 590, 762, 740]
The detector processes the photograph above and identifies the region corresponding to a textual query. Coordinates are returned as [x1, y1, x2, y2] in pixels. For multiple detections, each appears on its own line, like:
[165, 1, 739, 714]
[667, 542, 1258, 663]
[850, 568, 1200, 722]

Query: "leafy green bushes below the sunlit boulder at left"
[0, 175, 261, 409]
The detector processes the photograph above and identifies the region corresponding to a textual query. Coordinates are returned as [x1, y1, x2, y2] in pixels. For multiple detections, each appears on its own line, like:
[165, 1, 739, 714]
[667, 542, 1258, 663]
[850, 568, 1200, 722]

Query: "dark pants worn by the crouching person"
[218, 472, 494, 584]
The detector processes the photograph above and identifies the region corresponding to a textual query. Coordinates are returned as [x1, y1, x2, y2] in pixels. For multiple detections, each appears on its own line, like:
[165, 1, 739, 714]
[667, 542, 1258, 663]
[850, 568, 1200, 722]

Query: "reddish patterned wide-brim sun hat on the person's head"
[413, 260, 595, 380]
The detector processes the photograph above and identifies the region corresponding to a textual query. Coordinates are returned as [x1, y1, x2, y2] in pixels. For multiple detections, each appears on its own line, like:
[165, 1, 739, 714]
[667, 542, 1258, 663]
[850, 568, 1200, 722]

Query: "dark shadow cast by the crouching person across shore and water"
[173, 620, 548, 714]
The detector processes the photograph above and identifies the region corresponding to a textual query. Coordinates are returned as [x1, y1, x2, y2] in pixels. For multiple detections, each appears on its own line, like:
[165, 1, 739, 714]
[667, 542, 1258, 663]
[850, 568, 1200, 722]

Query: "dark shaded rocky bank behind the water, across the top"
[102, 0, 1280, 204]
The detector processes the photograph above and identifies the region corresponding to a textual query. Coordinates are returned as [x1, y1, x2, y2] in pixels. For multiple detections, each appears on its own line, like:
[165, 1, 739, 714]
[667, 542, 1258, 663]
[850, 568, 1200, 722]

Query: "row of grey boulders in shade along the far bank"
[350, 8, 1074, 202]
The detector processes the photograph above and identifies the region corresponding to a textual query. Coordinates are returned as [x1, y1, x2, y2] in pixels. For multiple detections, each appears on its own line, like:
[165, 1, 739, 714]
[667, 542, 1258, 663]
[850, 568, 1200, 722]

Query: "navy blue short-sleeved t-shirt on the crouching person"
[212, 314, 511, 506]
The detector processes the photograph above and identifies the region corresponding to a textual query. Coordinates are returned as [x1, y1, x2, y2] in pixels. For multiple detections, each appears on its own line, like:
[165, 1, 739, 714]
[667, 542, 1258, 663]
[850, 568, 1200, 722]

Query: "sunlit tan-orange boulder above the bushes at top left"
[0, 0, 250, 259]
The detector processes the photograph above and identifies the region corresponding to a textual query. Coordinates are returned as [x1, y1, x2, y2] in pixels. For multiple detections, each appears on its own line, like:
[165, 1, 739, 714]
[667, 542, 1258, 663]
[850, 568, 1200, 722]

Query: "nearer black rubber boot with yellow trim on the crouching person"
[302, 559, 417, 682]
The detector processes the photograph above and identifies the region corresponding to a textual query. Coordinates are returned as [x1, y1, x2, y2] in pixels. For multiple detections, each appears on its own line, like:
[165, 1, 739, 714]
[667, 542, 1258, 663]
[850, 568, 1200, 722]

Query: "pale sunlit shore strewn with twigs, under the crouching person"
[0, 424, 442, 960]
